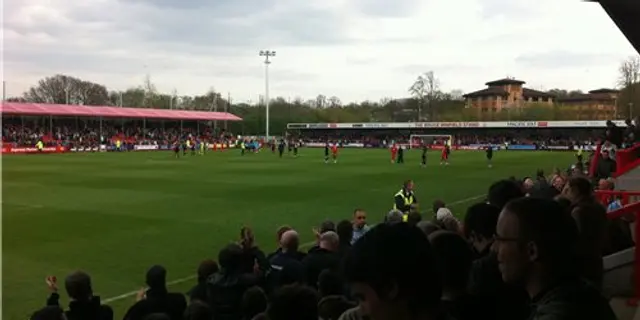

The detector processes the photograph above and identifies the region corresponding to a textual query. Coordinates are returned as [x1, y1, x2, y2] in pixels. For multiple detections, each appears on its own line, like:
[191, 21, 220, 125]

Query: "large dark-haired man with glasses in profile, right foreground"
[494, 198, 616, 320]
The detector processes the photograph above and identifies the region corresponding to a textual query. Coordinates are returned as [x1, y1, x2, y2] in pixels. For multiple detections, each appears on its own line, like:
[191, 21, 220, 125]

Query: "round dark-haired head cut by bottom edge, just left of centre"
[267, 285, 318, 320]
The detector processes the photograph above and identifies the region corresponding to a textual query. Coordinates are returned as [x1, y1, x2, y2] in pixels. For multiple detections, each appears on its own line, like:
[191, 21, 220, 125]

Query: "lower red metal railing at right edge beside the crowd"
[596, 191, 640, 306]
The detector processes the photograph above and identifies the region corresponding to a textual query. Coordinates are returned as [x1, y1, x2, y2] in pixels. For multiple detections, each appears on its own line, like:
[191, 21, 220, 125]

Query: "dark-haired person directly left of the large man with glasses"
[464, 203, 529, 320]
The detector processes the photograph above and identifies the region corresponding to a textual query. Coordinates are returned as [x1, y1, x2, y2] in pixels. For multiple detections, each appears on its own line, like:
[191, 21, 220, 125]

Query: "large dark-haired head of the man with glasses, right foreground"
[493, 198, 578, 297]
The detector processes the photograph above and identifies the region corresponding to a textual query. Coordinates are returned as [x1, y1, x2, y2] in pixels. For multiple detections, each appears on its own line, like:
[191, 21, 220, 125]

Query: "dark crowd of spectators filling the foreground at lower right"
[31, 165, 633, 320]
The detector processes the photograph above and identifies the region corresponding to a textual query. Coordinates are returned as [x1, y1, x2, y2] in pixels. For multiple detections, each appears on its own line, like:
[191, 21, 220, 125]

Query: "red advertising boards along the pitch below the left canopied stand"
[2, 143, 230, 154]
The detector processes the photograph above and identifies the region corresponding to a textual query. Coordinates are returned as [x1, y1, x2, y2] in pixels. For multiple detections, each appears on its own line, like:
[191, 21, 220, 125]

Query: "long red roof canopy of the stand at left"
[0, 102, 242, 121]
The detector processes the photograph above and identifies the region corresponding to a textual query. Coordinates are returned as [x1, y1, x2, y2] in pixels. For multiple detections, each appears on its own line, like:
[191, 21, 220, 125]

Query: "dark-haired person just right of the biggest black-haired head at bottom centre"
[429, 230, 484, 320]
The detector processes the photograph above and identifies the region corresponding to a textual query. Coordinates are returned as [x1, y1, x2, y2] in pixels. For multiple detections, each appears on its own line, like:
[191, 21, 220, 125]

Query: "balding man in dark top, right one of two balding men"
[302, 231, 340, 288]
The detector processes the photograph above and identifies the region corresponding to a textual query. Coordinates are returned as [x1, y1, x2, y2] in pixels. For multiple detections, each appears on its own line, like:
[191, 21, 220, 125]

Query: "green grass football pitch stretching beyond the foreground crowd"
[2, 149, 573, 319]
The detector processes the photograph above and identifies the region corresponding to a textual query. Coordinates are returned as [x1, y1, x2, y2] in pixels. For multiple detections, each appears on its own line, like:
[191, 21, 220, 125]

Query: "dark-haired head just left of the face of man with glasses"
[464, 203, 500, 252]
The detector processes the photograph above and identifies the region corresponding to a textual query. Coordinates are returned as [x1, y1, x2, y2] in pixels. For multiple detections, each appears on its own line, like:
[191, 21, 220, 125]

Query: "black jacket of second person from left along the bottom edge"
[123, 289, 187, 320]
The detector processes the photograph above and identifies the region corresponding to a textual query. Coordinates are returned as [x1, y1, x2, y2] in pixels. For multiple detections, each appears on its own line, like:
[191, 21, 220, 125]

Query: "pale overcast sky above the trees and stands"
[3, 0, 635, 101]
